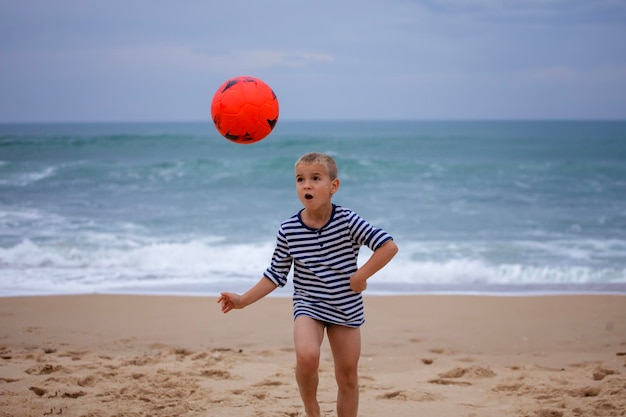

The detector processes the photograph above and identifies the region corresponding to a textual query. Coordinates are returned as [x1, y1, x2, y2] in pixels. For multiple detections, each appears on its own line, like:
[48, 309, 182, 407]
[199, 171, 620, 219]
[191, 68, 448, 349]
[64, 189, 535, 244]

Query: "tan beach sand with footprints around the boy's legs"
[0, 295, 626, 417]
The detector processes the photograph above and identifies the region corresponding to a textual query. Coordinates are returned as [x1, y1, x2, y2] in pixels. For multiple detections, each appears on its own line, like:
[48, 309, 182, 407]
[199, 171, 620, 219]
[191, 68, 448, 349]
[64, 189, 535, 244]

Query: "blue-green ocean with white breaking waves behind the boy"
[0, 121, 626, 297]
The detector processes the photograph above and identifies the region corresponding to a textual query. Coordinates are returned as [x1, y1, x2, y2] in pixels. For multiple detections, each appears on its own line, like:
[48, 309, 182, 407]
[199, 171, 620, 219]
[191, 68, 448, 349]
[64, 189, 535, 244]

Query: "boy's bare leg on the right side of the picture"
[327, 325, 361, 417]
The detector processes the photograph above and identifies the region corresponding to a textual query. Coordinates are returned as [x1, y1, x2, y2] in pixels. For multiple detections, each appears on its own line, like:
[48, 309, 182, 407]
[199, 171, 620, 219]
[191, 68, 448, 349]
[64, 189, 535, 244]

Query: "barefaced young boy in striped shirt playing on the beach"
[217, 152, 398, 417]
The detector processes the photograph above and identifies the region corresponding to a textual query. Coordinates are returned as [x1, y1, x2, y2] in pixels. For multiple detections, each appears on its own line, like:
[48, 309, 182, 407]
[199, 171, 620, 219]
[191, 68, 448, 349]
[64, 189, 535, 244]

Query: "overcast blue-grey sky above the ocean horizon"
[0, 0, 626, 122]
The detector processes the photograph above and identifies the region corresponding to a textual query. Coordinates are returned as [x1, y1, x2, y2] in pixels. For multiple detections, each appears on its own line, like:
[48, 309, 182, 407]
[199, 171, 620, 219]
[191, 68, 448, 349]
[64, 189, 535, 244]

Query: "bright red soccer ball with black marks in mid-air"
[211, 76, 278, 144]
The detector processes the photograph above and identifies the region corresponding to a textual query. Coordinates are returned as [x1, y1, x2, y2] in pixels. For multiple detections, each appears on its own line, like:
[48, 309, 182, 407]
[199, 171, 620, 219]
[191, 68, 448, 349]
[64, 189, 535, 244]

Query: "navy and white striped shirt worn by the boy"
[264, 204, 392, 327]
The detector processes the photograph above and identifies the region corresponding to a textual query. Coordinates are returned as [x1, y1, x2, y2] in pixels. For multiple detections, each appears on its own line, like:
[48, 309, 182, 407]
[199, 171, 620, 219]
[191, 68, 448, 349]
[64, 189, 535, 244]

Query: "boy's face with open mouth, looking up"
[296, 163, 339, 209]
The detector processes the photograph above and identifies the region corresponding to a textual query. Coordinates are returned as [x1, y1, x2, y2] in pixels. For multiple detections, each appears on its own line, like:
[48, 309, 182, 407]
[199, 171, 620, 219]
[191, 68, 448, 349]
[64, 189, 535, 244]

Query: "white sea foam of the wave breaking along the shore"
[0, 239, 626, 295]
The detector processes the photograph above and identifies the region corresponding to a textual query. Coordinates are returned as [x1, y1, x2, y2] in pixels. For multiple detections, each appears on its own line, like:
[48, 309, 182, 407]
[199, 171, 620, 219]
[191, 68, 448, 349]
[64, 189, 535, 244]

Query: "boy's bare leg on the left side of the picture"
[293, 316, 324, 417]
